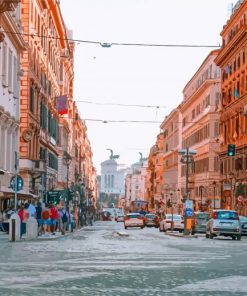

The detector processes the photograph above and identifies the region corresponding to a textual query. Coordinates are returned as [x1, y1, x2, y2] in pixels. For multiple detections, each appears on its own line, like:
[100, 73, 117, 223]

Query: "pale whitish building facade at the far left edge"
[0, 1, 28, 210]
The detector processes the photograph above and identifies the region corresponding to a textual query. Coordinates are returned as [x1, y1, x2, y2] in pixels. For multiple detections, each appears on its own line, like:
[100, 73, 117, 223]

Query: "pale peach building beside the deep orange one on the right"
[178, 50, 221, 210]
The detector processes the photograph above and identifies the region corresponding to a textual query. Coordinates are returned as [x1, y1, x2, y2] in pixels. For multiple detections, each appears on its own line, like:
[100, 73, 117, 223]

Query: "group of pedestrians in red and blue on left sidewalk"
[14, 201, 76, 235]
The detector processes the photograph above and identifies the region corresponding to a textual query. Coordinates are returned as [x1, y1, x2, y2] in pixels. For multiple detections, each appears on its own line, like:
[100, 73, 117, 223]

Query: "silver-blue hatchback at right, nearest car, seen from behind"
[206, 210, 241, 240]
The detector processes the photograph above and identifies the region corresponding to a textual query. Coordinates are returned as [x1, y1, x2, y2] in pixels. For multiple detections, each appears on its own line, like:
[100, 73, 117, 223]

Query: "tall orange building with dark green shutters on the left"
[20, 0, 73, 197]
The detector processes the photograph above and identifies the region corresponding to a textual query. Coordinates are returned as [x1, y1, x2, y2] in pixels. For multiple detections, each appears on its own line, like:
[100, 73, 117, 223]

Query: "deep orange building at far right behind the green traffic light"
[216, 1, 247, 215]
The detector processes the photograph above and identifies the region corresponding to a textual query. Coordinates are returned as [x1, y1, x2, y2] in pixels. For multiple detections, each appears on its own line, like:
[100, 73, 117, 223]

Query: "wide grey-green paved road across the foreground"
[0, 222, 247, 296]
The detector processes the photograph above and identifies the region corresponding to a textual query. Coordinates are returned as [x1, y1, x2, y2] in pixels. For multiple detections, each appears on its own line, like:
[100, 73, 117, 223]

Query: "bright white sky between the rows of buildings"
[60, 0, 237, 174]
